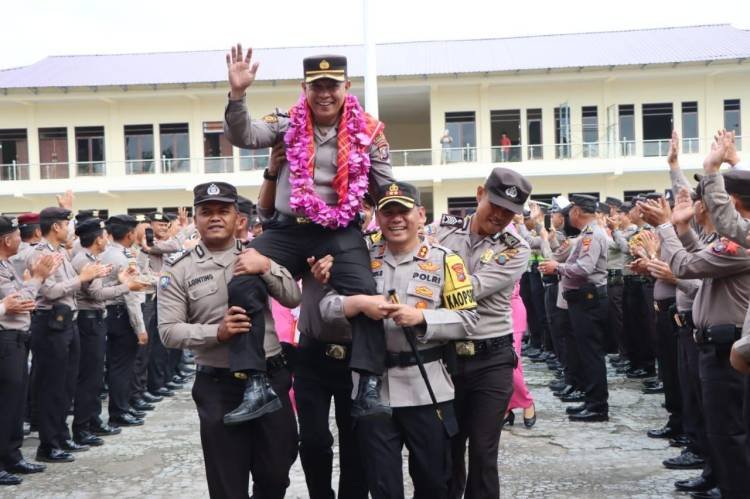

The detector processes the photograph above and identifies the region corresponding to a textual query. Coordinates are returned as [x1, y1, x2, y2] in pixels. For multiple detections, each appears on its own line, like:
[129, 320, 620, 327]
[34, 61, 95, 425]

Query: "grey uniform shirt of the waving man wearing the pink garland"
[224, 97, 395, 216]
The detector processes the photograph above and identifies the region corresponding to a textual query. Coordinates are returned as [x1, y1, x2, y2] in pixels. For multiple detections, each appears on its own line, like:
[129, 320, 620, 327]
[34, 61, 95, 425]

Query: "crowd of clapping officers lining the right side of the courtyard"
[516, 131, 750, 498]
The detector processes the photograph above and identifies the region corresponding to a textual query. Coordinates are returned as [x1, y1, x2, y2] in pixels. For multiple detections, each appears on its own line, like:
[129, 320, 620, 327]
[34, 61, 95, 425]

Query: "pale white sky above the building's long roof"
[0, 0, 750, 69]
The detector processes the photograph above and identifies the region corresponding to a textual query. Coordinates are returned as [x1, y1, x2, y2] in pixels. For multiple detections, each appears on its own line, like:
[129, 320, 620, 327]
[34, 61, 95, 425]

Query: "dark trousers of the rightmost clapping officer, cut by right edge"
[698, 344, 750, 499]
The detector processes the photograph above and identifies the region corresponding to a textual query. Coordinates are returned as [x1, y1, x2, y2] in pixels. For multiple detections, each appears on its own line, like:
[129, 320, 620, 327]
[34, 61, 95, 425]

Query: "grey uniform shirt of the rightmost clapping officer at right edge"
[657, 224, 750, 328]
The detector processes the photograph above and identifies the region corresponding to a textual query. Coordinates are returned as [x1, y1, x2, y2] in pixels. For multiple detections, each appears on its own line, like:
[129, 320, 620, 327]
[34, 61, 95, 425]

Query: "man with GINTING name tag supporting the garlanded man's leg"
[157, 182, 300, 498]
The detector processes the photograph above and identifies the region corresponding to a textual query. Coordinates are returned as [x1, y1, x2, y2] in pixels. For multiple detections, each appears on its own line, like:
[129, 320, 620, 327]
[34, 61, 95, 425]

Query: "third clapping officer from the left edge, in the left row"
[72, 218, 145, 446]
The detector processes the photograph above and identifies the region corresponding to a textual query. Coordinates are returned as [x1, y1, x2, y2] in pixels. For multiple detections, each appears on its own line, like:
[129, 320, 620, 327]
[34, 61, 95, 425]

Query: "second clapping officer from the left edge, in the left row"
[27, 208, 108, 463]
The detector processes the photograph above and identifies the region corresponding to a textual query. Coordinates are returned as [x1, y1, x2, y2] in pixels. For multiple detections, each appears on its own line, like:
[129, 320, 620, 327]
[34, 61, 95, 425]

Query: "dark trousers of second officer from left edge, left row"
[31, 310, 80, 449]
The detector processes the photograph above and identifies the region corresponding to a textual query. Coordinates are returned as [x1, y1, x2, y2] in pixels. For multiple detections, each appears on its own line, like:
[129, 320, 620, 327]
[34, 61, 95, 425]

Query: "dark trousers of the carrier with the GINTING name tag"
[193, 367, 297, 499]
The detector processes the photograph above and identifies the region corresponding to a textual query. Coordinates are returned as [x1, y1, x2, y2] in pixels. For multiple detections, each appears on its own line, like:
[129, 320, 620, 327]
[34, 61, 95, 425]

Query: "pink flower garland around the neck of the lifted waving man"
[284, 94, 371, 229]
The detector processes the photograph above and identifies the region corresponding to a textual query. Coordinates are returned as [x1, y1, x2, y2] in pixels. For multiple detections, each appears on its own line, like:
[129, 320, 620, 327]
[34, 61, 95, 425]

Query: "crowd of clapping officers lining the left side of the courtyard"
[0, 201, 210, 485]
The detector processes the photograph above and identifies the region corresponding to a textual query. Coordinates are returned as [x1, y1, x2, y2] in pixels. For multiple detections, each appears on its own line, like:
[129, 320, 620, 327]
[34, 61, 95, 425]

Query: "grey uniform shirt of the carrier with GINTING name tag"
[157, 239, 301, 368]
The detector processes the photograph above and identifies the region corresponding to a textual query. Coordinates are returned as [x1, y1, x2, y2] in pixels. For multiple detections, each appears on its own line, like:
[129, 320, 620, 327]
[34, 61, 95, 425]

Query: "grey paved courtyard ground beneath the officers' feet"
[0, 361, 699, 499]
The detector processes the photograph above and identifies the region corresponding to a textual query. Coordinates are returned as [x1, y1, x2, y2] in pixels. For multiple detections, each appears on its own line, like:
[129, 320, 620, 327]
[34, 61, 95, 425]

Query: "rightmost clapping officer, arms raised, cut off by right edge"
[642, 175, 750, 498]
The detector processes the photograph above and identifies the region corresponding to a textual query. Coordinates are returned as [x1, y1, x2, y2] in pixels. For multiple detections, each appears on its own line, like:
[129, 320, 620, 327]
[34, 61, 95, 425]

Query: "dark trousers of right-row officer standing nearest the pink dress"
[564, 286, 609, 412]
